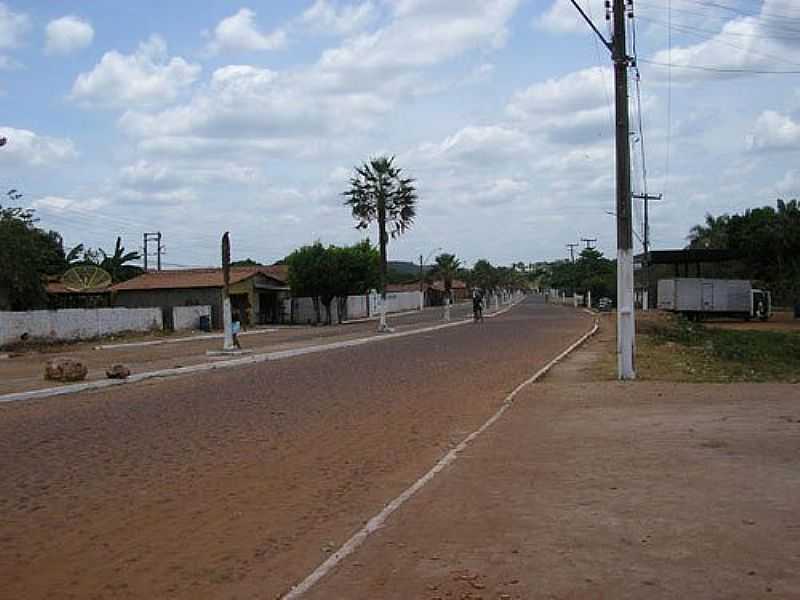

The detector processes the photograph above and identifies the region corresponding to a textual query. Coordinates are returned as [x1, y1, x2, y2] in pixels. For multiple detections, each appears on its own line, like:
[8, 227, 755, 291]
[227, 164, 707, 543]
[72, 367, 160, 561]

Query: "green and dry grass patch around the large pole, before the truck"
[596, 313, 800, 383]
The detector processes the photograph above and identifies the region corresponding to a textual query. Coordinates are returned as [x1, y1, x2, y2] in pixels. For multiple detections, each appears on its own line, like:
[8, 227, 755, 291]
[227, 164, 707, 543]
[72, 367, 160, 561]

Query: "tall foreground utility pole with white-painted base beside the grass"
[611, 0, 636, 380]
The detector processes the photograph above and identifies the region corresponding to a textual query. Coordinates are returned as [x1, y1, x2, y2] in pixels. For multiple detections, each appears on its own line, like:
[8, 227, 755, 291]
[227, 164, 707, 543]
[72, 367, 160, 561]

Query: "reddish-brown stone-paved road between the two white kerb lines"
[0, 300, 590, 600]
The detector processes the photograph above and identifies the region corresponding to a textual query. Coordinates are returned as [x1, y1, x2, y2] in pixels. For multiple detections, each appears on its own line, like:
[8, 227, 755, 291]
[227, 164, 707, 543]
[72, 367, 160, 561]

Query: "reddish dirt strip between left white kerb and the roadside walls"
[0, 304, 478, 395]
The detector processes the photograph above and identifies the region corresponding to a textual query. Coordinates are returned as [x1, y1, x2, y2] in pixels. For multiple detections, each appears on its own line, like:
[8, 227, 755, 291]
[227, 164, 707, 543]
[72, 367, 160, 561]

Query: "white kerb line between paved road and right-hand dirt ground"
[282, 315, 600, 600]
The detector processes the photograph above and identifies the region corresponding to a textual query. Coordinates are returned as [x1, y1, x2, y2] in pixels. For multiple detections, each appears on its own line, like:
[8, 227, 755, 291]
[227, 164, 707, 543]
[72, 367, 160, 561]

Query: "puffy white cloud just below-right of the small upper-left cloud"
[71, 35, 201, 108]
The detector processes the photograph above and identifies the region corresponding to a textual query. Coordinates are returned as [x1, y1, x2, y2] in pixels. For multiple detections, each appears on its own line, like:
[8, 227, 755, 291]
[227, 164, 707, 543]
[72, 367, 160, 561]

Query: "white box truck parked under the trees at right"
[658, 278, 772, 321]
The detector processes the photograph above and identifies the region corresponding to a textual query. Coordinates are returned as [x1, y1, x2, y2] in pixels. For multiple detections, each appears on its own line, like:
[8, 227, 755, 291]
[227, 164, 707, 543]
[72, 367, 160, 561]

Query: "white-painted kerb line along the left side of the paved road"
[0, 296, 525, 404]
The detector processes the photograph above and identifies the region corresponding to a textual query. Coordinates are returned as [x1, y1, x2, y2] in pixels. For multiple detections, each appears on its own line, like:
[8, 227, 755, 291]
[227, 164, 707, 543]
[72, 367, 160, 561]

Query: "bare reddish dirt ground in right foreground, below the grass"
[307, 383, 800, 600]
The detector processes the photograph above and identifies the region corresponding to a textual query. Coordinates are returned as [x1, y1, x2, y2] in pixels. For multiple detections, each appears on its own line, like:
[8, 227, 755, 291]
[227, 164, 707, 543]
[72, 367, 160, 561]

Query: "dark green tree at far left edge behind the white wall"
[0, 203, 67, 310]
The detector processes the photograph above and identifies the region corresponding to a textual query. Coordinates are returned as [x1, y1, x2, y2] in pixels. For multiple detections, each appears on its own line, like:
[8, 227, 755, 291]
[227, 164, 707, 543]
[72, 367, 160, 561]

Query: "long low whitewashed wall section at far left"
[0, 308, 162, 345]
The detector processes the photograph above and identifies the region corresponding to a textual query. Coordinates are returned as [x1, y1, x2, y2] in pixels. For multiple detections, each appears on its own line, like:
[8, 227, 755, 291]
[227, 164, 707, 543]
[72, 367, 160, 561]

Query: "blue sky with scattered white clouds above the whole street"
[0, 0, 800, 267]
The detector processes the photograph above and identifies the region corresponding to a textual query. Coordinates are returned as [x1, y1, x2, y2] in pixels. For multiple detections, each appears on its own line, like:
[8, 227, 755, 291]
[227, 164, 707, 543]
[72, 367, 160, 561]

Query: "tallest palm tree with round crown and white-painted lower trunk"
[342, 156, 417, 331]
